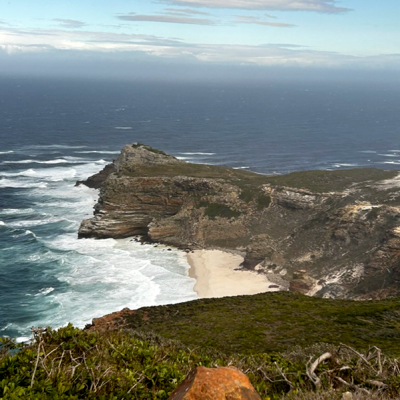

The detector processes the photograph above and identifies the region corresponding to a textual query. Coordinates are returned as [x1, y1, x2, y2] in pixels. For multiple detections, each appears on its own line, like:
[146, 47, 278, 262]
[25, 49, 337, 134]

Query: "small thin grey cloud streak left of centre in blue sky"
[117, 9, 215, 25]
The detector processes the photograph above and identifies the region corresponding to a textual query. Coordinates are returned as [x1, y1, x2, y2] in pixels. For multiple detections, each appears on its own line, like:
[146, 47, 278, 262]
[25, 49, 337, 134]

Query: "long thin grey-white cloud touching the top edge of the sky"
[162, 0, 351, 13]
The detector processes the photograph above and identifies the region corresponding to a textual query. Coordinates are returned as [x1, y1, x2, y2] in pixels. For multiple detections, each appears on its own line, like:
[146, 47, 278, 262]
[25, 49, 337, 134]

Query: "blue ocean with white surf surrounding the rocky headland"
[0, 78, 400, 338]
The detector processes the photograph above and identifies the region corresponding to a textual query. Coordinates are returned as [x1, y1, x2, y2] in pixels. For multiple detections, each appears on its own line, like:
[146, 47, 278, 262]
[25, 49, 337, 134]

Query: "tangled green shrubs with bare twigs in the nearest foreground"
[0, 325, 400, 400]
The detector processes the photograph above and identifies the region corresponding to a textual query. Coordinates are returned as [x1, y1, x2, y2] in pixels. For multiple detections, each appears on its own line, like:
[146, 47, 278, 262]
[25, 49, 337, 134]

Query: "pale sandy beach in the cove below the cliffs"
[187, 250, 278, 298]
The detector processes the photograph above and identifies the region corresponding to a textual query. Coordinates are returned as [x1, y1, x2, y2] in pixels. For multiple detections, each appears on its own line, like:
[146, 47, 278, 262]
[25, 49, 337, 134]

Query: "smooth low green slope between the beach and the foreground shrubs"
[109, 292, 400, 356]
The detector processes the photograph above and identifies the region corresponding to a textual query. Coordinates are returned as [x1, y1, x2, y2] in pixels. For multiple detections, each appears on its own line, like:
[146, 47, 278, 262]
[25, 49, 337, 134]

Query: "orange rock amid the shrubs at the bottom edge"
[168, 367, 261, 400]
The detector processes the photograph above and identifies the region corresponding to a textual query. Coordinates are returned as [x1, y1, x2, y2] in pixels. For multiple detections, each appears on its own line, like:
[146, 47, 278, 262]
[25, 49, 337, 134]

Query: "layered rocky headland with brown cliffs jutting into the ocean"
[79, 144, 400, 298]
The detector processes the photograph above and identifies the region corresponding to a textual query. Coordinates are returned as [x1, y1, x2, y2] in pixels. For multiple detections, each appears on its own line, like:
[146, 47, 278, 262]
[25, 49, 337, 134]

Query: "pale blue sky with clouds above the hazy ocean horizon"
[0, 0, 400, 80]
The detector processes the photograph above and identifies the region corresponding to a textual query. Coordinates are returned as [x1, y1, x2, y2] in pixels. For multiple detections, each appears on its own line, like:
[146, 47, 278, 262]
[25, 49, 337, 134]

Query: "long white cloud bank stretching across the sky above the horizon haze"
[0, 28, 400, 70]
